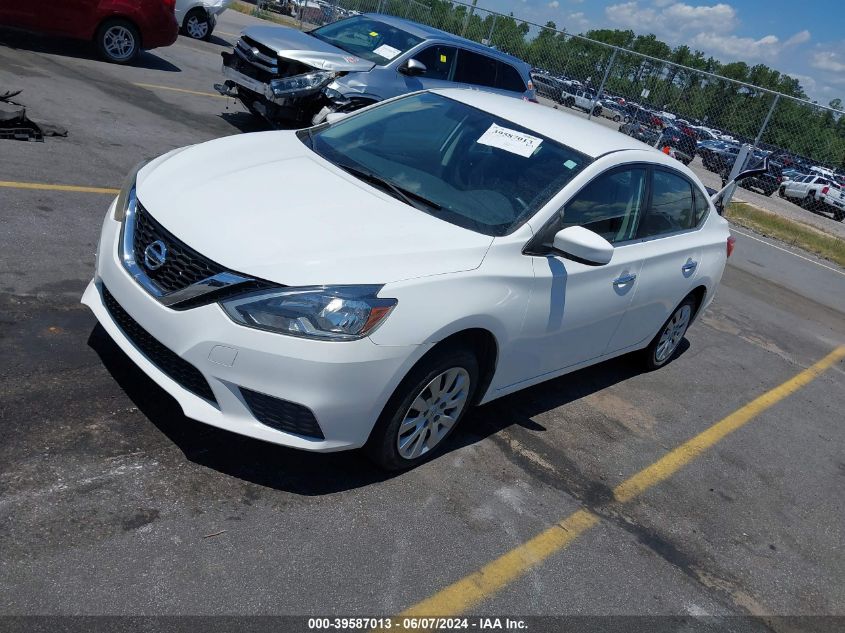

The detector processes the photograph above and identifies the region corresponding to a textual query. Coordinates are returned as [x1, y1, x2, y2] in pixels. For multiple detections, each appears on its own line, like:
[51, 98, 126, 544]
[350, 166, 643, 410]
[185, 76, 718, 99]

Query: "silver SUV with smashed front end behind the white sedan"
[215, 14, 535, 126]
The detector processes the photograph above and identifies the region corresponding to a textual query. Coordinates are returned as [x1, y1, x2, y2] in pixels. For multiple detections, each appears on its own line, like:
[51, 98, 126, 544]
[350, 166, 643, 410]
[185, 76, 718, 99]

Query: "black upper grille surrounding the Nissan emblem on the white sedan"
[132, 203, 226, 293]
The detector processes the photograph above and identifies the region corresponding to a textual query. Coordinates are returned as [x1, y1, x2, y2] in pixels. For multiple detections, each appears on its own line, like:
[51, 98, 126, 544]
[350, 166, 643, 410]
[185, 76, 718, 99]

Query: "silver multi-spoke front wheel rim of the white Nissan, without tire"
[396, 367, 470, 459]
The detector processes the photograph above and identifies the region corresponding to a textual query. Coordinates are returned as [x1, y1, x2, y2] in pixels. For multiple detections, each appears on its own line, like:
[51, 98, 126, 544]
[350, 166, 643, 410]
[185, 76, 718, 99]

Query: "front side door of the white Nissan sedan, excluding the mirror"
[524, 166, 648, 375]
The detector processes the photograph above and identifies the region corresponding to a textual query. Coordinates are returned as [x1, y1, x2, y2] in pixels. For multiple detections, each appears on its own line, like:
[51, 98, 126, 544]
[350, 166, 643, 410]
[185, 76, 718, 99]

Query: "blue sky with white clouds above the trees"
[478, 0, 845, 105]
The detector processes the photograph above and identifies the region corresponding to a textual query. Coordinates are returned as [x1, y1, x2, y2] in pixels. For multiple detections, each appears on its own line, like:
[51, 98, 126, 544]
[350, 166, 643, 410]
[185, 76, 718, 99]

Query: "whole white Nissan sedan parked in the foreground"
[83, 89, 732, 469]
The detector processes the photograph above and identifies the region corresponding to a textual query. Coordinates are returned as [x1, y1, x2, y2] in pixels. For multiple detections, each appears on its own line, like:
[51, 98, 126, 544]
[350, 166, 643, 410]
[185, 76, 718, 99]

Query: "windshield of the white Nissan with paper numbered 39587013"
[301, 93, 592, 235]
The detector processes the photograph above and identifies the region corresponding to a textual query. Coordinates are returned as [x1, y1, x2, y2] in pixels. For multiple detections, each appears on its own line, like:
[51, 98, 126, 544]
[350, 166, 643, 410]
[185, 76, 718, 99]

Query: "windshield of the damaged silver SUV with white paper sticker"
[311, 15, 423, 66]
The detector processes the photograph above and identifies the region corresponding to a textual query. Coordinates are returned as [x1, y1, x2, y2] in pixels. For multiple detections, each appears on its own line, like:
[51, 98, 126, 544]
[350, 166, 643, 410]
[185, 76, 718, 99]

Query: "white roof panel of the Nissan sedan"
[432, 88, 648, 158]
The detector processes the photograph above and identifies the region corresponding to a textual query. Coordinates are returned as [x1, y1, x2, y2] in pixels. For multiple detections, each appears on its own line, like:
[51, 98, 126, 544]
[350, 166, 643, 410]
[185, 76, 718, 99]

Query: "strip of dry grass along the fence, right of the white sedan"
[725, 202, 845, 266]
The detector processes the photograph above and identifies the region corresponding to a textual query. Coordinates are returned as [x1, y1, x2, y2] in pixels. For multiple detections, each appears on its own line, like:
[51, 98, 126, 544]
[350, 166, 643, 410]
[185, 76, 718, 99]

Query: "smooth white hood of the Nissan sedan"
[137, 131, 493, 286]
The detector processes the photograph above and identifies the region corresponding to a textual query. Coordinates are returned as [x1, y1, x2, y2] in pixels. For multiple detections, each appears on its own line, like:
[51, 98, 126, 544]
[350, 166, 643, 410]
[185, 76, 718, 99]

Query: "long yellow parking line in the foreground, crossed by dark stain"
[390, 345, 845, 617]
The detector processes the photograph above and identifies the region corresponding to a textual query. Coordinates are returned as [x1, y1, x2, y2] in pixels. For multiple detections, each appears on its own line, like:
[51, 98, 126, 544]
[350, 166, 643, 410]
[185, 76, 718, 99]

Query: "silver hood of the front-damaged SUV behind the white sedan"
[241, 26, 375, 72]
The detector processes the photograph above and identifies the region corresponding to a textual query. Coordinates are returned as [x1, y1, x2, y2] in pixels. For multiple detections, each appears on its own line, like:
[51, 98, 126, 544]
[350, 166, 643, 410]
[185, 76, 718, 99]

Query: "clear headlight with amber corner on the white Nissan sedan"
[220, 286, 396, 341]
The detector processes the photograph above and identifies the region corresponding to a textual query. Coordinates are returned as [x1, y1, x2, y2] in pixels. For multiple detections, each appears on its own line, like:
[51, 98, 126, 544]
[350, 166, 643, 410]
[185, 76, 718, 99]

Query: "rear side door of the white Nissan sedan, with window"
[608, 166, 712, 353]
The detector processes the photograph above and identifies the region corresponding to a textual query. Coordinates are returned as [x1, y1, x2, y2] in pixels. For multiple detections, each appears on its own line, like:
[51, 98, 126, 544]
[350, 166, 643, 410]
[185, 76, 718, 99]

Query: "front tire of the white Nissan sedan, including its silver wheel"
[365, 347, 479, 470]
